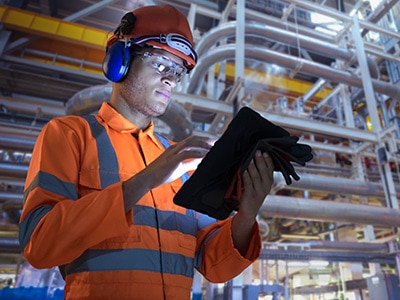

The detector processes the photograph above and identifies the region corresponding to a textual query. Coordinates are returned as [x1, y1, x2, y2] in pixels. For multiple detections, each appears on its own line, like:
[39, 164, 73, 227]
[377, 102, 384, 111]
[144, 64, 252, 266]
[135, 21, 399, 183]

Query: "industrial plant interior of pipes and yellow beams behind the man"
[0, 0, 400, 300]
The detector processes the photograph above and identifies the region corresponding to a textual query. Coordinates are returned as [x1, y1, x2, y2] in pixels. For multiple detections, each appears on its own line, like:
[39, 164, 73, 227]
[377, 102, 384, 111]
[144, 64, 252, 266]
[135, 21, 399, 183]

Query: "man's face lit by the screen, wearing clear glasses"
[118, 48, 185, 117]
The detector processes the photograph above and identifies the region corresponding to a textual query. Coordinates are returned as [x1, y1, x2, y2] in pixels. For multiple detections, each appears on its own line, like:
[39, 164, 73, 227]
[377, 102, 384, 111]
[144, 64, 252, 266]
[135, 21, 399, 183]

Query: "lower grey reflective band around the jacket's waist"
[66, 249, 193, 278]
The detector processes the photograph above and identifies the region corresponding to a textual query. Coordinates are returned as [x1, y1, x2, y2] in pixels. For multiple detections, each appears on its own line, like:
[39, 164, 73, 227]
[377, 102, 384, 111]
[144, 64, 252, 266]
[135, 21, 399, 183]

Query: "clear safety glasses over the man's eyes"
[138, 52, 188, 82]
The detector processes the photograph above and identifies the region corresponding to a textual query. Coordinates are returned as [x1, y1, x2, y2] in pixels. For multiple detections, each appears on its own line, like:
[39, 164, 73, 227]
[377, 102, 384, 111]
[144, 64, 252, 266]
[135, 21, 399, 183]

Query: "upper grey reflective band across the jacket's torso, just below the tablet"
[133, 205, 197, 236]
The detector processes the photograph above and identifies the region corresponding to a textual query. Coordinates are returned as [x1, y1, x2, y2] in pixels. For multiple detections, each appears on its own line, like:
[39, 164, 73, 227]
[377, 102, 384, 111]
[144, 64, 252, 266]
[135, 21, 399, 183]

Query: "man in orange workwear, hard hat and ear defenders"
[20, 5, 273, 300]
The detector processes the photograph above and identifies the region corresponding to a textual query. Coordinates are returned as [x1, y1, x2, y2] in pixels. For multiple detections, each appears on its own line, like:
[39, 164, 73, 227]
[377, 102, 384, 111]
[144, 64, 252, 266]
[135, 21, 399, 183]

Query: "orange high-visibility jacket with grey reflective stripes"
[19, 103, 261, 300]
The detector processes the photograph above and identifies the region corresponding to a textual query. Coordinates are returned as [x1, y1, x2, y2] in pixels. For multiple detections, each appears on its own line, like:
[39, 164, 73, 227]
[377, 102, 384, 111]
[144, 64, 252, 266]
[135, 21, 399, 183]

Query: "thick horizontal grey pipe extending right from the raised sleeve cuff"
[259, 195, 400, 227]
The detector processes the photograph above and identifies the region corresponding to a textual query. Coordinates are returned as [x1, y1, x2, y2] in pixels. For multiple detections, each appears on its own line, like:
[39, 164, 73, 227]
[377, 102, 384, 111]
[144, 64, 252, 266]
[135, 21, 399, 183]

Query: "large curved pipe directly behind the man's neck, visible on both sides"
[66, 84, 193, 141]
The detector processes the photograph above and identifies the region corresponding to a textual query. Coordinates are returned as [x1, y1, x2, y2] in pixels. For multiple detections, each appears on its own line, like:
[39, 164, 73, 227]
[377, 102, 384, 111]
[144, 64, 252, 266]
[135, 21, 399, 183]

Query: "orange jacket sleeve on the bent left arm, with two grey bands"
[19, 119, 129, 268]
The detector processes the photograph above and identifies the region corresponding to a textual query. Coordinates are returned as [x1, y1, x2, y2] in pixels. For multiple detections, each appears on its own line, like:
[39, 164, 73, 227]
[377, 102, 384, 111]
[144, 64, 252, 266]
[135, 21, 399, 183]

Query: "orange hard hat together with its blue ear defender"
[103, 5, 197, 82]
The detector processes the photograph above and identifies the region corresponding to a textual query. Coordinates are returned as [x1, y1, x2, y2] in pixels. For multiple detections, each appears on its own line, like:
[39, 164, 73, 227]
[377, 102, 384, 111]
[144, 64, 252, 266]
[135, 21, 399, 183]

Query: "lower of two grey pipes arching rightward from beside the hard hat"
[187, 45, 400, 98]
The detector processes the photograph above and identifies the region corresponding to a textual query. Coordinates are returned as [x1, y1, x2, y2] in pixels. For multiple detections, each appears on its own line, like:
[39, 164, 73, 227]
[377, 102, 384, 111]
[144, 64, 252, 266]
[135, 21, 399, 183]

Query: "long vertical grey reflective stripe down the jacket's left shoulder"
[83, 115, 120, 189]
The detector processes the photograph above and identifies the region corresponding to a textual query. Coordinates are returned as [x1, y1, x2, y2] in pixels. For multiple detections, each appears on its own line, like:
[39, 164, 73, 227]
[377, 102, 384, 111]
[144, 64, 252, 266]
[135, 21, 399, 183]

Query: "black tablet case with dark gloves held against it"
[174, 107, 313, 220]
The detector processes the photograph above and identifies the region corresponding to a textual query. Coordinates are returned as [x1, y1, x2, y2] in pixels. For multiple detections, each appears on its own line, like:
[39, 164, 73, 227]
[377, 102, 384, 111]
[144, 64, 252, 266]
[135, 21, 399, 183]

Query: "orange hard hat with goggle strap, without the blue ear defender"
[107, 5, 197, 70]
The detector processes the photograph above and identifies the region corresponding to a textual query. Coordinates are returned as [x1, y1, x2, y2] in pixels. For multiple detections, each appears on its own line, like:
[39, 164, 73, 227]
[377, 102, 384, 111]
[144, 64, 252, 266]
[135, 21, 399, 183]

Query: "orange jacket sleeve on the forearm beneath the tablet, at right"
[195, 215, 261, 283]
